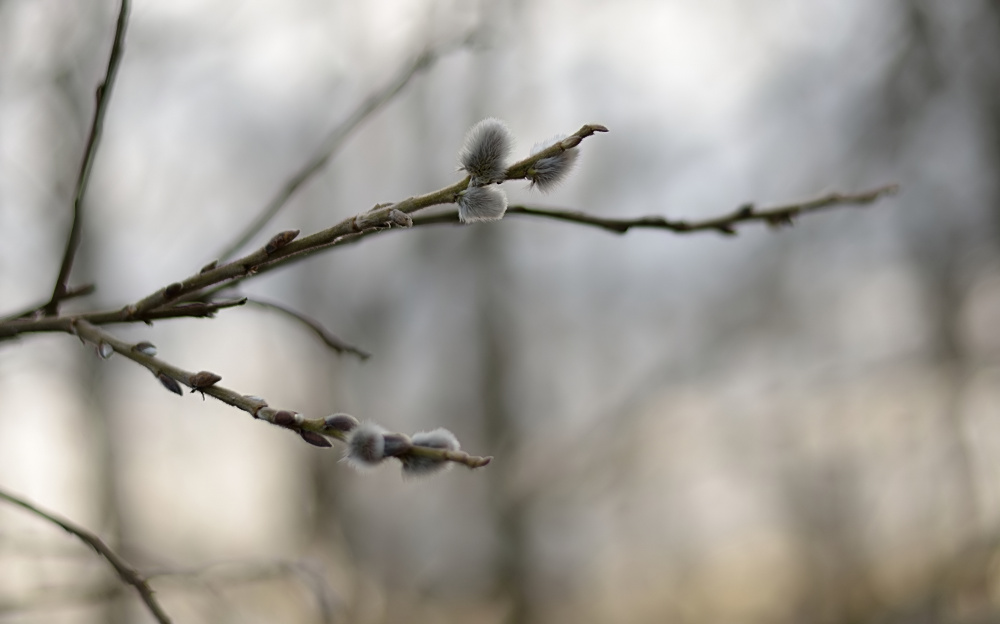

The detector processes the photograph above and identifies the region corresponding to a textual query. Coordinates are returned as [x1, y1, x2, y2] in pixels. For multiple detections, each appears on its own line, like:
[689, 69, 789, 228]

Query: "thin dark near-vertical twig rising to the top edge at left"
[43, 0, 129, 316]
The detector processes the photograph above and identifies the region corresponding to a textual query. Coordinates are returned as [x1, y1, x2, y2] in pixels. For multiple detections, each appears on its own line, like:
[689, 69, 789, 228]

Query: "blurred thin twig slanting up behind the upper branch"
[218, 37, 470, 262]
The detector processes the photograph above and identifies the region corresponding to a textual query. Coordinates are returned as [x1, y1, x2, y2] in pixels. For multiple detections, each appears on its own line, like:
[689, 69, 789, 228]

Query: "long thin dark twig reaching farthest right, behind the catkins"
[404, 184, 899, 236]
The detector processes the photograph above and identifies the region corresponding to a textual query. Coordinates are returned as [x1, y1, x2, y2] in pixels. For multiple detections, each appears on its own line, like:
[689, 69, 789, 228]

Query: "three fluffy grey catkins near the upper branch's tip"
[458, 117, 578, 223]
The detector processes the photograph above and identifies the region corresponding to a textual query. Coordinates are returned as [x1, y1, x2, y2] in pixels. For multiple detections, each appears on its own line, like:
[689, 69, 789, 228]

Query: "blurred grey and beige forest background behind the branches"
[0, 0, 1000, 624]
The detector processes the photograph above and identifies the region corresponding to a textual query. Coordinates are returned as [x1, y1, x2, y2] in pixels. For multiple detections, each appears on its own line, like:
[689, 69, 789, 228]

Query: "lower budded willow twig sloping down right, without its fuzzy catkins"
[71, 320, 492, 468]
